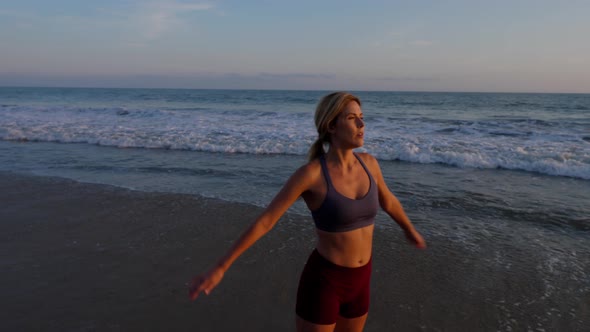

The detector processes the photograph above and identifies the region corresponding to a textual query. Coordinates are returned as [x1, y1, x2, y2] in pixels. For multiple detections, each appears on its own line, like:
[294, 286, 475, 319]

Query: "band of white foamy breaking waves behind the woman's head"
[0, 107, 590, 179]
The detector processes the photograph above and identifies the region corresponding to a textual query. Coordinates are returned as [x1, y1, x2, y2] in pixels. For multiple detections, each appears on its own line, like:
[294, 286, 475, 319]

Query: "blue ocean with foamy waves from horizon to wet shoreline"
[0, 88, 590, 331]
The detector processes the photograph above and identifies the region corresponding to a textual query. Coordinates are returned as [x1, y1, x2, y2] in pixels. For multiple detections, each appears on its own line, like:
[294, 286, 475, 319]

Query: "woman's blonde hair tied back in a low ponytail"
[308, 92, 361, 161]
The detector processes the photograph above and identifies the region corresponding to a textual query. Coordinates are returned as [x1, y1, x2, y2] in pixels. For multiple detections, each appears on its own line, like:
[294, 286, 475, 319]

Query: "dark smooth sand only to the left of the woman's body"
[0, 174, 320, 331]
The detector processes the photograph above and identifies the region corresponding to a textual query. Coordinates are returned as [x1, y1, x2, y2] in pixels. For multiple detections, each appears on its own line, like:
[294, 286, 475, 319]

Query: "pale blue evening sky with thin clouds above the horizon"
[0, 0, 590, 93]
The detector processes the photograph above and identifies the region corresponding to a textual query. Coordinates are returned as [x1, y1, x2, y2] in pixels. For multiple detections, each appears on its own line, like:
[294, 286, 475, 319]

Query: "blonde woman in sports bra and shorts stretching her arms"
[189, 92, 426, 331]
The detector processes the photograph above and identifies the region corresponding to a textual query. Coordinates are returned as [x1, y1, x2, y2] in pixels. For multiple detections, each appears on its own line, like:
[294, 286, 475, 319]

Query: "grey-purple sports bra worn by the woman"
[311, 154, 379, 232]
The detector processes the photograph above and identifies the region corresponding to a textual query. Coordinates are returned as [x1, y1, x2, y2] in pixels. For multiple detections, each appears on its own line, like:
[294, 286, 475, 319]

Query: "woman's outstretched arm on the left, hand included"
[189, 164, 320, 300]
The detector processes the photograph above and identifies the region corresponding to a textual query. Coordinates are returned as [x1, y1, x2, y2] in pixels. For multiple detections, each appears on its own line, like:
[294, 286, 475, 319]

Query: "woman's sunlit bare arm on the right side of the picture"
[363, 154, 426, 248]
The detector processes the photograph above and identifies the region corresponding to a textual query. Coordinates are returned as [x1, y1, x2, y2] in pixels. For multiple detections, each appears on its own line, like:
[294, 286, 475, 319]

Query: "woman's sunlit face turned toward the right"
[329, 101, 365, 149]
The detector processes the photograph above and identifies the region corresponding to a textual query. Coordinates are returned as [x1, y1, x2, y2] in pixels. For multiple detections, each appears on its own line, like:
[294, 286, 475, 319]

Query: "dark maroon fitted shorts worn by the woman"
[295, 249, 372, 325]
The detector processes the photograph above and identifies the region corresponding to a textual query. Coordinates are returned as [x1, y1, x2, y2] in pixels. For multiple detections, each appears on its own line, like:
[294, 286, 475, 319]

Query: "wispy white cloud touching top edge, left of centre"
[132, 1, 213, 40]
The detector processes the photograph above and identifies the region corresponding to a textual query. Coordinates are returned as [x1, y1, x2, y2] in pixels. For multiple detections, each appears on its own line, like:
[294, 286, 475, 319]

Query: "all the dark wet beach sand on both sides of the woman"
[0, 173, 588, 331]
